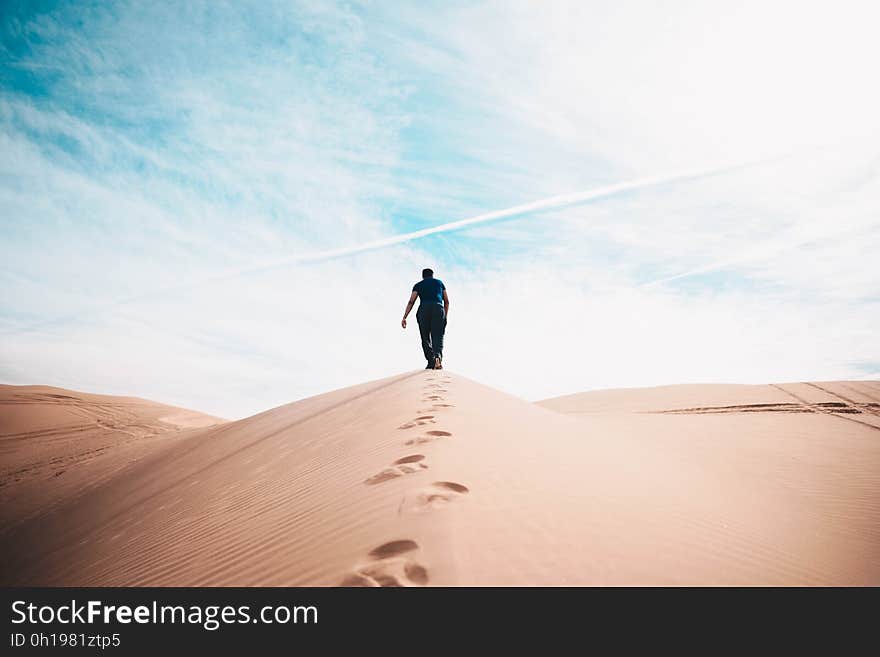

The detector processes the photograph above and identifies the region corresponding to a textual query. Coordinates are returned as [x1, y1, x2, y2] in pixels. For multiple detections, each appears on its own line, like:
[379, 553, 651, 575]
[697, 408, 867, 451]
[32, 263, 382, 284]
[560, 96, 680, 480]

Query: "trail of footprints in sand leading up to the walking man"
[341, 376, 469, 586]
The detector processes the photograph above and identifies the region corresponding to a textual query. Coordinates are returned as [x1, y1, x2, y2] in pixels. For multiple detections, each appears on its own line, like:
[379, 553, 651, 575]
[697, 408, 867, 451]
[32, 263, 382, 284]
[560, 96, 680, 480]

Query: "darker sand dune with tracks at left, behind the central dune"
[0, 385, 223, 527]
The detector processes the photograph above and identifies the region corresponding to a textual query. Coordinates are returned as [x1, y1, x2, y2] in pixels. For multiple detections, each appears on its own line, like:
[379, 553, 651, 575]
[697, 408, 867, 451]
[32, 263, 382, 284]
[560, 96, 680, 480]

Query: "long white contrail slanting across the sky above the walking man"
[5, 157, 768, 335]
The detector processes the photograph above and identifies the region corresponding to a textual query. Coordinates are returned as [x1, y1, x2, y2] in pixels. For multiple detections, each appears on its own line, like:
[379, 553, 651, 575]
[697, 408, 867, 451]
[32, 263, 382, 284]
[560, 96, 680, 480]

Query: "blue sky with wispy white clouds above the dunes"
[0, 0, 880, 418]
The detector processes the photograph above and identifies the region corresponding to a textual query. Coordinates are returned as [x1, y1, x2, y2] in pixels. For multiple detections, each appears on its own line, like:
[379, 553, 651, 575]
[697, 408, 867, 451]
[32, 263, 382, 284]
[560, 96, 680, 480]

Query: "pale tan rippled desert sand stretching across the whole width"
[0, 370, 880, 586]
